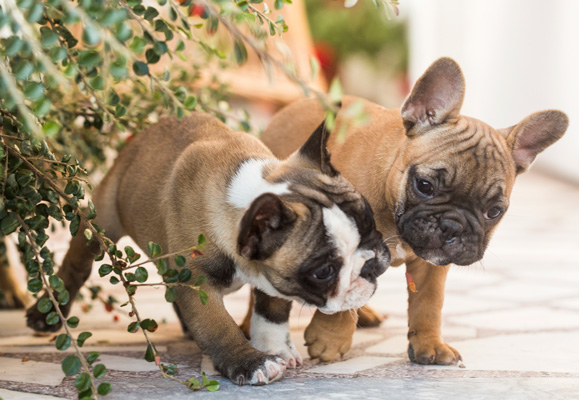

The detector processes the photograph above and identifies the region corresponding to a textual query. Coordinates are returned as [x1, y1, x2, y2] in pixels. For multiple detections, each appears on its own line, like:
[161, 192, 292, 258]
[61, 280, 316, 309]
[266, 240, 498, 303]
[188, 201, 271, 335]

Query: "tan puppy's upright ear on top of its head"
[400, 58, 464, 136]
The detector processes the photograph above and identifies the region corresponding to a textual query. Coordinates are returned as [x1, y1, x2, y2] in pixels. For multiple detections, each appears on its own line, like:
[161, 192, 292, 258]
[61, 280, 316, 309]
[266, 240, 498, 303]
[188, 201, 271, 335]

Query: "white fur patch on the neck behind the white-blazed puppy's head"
[227, 159, 289, 209]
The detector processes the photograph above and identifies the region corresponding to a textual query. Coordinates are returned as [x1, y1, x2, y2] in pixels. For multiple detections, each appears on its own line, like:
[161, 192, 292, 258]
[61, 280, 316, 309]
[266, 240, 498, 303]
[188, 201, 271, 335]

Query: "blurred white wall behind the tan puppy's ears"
[400, 0, 579, 183]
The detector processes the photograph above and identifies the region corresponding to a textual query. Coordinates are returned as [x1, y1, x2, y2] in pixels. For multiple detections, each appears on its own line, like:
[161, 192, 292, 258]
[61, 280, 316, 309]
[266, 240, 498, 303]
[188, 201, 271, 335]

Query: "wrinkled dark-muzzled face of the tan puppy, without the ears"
[395, 119, 515, 265]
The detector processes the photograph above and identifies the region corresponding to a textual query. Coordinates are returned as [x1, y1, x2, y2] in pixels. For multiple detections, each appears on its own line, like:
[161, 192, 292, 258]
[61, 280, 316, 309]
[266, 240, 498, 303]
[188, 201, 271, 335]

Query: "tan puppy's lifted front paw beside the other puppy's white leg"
[304, 311, 357, 362]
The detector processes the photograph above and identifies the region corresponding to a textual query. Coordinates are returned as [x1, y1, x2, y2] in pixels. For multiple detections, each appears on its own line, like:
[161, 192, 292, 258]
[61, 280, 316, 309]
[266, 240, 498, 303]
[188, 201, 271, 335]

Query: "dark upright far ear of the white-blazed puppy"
[293, 120, 339, 177]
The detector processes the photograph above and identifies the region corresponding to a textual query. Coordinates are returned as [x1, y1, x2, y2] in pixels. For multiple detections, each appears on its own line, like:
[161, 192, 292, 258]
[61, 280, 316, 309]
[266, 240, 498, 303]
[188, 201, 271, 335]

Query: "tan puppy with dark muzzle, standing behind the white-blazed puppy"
[262, 58, 568, 364]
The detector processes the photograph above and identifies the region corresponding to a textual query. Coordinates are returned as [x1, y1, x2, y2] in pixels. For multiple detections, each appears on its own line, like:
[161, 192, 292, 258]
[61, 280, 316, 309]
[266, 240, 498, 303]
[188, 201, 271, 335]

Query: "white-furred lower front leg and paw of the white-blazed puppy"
[251, 312, 303, 368]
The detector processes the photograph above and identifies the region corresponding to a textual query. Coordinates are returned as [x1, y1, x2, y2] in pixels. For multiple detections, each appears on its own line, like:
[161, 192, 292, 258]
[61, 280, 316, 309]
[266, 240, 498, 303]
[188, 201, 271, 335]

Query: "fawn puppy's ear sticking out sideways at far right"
[499, 110, 569, 174]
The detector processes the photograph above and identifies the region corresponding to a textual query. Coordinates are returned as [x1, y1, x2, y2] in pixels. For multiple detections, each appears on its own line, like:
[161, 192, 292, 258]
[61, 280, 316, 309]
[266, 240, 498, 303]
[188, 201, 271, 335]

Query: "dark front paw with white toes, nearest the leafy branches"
[220, 352, 287, 386]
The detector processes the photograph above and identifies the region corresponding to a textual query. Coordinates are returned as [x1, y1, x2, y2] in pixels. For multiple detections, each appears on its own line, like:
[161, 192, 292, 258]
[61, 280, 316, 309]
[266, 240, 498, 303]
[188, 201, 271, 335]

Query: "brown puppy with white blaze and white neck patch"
[28, 113, 390, 385]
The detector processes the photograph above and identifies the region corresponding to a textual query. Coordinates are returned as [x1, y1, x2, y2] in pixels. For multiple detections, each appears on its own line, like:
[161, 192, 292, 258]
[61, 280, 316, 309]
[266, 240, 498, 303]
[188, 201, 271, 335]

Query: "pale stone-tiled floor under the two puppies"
[0, 172, 579, 400]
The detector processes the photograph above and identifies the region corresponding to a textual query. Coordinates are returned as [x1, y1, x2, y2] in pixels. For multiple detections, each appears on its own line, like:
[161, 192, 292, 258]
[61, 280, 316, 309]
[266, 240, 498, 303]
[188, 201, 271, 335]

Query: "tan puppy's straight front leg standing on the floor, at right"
[406, 257, 462, 365]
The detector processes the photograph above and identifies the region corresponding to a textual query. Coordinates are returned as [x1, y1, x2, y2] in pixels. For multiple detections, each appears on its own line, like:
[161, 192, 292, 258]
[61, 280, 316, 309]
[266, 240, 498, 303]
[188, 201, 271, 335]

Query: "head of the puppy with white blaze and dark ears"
[237, 120, 390, 313]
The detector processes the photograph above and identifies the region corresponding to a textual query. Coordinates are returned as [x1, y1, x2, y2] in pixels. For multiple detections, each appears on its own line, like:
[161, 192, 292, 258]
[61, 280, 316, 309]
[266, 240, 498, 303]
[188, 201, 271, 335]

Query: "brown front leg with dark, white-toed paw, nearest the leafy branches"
[177, 287, 287, 385]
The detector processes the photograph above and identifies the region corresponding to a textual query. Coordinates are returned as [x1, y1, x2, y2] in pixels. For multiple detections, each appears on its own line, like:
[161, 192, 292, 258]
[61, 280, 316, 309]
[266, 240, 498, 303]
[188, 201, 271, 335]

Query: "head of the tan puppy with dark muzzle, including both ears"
[387, 58, 568, 265]
